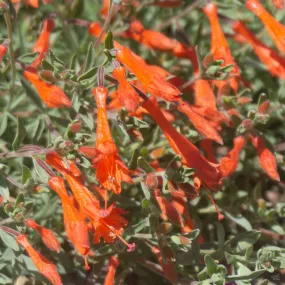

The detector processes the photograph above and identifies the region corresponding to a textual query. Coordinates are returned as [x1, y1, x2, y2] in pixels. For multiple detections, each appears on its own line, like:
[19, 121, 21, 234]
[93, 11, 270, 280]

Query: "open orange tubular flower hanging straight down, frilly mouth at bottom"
[93, 87, 132, 194]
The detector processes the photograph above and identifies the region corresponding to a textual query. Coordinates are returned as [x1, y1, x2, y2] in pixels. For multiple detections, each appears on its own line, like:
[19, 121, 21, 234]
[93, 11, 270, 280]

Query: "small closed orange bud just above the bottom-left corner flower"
[25, 219, 60, 253]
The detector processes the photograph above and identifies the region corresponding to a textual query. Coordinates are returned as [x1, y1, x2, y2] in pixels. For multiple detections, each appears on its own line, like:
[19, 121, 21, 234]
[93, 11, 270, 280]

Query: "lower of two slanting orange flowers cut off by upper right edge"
[233, 21, 285, 79]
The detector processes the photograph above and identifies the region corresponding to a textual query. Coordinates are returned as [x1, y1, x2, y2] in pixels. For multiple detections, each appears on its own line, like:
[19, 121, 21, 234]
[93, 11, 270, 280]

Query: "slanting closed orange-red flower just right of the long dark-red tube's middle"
[178, 102, 223, 144]
